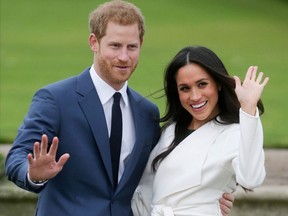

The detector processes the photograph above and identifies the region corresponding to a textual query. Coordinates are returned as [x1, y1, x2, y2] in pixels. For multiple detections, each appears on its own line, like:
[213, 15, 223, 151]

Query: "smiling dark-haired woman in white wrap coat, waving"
[132, 47, 269, 216]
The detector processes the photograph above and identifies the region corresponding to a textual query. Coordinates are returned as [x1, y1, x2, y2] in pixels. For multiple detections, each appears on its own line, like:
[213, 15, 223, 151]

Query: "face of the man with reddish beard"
[90, 22, 141, 90]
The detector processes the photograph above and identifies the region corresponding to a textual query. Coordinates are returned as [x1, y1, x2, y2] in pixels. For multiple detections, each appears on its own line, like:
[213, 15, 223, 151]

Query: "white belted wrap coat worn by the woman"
[132, 109, 265, 216]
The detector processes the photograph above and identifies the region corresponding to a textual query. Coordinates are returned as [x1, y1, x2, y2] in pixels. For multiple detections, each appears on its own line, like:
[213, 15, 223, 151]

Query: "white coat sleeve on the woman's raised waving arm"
[232, 109, 266, 189]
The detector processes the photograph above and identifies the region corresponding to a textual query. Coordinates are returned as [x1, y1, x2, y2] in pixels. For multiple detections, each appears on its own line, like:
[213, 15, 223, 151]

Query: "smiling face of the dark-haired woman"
[175, 63, 219, 129]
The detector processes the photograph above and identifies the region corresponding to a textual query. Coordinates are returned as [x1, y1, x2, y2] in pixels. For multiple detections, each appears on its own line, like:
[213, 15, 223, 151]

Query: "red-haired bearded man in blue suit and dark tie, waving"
[6, 1, 231, 216]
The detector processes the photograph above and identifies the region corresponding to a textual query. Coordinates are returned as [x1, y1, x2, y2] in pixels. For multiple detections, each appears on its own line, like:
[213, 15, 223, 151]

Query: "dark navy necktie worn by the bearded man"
[110, 92, 122, 189]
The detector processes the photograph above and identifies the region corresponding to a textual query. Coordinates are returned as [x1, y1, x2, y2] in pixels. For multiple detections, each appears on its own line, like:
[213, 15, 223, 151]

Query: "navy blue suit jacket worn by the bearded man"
[6, 68, 160, 216]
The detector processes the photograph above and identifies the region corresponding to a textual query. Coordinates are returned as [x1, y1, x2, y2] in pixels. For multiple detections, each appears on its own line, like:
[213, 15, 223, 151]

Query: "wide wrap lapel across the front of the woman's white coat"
[153, 121, 225, 203]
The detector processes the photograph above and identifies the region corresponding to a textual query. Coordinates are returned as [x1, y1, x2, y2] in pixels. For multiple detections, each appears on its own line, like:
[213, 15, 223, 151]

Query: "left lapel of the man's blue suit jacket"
[77, 69, 113, 184]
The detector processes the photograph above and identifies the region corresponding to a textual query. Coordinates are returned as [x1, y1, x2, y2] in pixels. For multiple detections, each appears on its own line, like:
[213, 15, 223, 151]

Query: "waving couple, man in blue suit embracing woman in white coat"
[6, 0, 268, 216]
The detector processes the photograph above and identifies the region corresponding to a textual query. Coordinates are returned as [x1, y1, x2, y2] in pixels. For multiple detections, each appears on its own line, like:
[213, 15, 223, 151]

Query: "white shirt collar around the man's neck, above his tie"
[89, 64, 128, 105]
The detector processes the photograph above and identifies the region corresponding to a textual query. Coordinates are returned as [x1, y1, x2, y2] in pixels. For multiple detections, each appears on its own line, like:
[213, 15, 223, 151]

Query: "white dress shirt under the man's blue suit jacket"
[90, 65, 136, 182]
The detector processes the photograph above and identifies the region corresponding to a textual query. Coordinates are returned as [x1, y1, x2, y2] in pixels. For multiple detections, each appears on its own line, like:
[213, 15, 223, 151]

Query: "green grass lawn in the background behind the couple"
[0, 0, 288, 147]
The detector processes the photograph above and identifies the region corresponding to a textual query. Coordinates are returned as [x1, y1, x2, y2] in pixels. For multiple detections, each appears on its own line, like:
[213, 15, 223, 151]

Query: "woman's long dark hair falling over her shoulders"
[152, 46, 264, 171]
